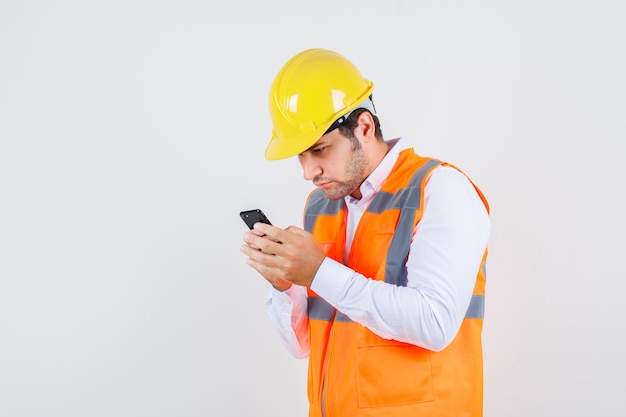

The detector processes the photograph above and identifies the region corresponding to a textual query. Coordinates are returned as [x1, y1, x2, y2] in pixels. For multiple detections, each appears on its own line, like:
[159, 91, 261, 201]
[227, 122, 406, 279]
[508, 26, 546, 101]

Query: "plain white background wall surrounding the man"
[0, 0, 626, 417]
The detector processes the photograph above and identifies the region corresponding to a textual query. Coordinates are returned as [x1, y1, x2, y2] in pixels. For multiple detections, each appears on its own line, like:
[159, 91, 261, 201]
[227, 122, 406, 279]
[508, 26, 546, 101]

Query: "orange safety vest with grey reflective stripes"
[304, 149, 489, 417]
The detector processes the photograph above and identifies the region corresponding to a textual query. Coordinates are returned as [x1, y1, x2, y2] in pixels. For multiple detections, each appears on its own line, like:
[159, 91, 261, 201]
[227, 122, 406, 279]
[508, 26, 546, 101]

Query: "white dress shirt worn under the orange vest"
[267, 139, 491, 358]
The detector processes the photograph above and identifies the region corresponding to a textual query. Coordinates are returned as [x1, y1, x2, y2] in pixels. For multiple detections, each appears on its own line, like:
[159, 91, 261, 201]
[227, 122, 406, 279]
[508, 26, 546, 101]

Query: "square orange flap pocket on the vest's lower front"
[356, 345, 433, 407]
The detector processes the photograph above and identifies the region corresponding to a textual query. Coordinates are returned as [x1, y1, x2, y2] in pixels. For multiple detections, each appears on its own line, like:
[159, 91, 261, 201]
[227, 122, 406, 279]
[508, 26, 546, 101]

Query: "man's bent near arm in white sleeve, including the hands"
[242, 167, 491, 350]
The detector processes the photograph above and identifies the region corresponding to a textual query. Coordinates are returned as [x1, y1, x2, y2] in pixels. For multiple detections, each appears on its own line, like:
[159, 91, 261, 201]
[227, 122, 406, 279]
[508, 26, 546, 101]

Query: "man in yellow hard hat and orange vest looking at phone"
[242, 49, 490, 417]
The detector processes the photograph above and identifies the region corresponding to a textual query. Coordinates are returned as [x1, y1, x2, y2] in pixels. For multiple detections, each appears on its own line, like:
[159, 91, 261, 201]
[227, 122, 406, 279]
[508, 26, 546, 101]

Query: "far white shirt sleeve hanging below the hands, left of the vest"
[266, 285, 310, 359]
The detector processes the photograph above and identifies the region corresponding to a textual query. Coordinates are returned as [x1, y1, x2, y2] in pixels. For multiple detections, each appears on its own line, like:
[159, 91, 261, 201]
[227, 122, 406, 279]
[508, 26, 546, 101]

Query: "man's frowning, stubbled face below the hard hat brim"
[298, 129, 367, 200]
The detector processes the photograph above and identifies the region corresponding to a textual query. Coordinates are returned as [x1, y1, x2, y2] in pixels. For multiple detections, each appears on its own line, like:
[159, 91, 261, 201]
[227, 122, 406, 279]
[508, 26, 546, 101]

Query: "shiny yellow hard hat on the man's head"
[265, 49, 374, 160]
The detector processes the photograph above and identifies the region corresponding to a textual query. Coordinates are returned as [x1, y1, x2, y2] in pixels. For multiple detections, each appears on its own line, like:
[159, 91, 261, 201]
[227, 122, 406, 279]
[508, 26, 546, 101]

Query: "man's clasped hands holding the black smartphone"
[241, 223, 326, 291]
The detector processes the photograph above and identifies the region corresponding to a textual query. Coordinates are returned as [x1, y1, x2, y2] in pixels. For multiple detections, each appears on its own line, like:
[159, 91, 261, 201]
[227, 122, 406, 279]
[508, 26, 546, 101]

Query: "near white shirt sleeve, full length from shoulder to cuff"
[311, 166, 491, 351]
